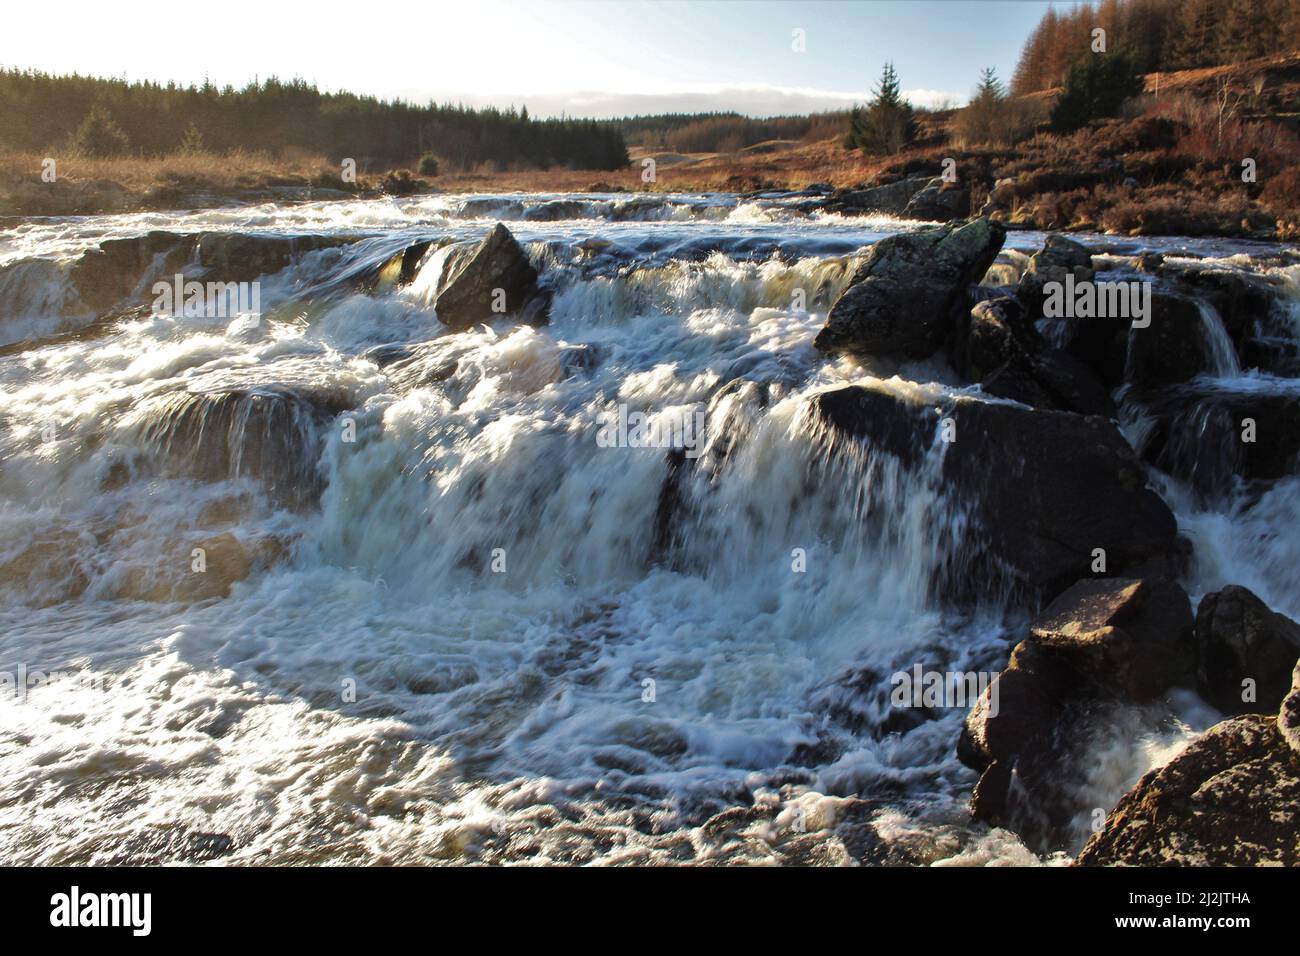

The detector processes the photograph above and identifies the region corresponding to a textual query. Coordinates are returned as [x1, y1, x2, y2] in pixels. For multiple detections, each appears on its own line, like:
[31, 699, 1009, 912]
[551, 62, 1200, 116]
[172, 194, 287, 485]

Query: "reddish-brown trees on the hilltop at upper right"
[1011, 0, 1300, 95]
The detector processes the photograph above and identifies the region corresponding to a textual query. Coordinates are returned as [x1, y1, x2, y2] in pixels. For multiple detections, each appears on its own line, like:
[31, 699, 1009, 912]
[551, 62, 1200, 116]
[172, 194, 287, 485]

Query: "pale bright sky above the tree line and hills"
[0, 0, 1050, 117]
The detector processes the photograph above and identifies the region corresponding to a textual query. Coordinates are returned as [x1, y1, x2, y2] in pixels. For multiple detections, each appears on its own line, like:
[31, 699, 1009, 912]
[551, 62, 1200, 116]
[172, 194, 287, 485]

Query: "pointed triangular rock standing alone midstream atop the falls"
[434, 222, 545, 332]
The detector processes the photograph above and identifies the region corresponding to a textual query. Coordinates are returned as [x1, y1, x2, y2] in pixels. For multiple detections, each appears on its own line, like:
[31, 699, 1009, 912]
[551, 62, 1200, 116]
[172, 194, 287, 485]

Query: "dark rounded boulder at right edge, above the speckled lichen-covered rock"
[1196, 584, 1300, 714]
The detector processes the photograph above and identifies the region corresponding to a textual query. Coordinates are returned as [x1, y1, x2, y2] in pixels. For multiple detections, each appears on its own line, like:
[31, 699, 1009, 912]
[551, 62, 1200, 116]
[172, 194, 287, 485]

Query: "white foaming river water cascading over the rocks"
[0, 195, 1300, 864]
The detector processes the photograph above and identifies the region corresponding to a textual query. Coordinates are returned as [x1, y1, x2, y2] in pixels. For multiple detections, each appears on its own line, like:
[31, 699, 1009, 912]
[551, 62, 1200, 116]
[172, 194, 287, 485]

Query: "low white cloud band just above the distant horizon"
[387, 85, 966, 120]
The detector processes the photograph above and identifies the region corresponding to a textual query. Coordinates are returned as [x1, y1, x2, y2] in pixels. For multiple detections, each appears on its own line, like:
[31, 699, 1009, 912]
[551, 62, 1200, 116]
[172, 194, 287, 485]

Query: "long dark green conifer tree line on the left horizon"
[0, 69, 629, 169]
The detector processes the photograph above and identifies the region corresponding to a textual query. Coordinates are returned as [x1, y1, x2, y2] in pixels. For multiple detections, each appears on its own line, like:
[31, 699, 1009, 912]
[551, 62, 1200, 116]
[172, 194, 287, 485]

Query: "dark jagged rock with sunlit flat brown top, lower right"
[957, 578, 1192, 848]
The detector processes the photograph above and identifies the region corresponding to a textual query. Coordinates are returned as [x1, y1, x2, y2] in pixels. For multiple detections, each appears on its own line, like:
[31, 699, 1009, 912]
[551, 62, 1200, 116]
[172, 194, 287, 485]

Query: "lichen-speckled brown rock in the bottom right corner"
[1076, 712, 1300, 866]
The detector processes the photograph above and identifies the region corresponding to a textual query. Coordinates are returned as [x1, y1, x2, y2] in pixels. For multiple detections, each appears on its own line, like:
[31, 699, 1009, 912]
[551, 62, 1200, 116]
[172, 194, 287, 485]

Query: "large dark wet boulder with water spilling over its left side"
[814, 386, 1177, 594]
